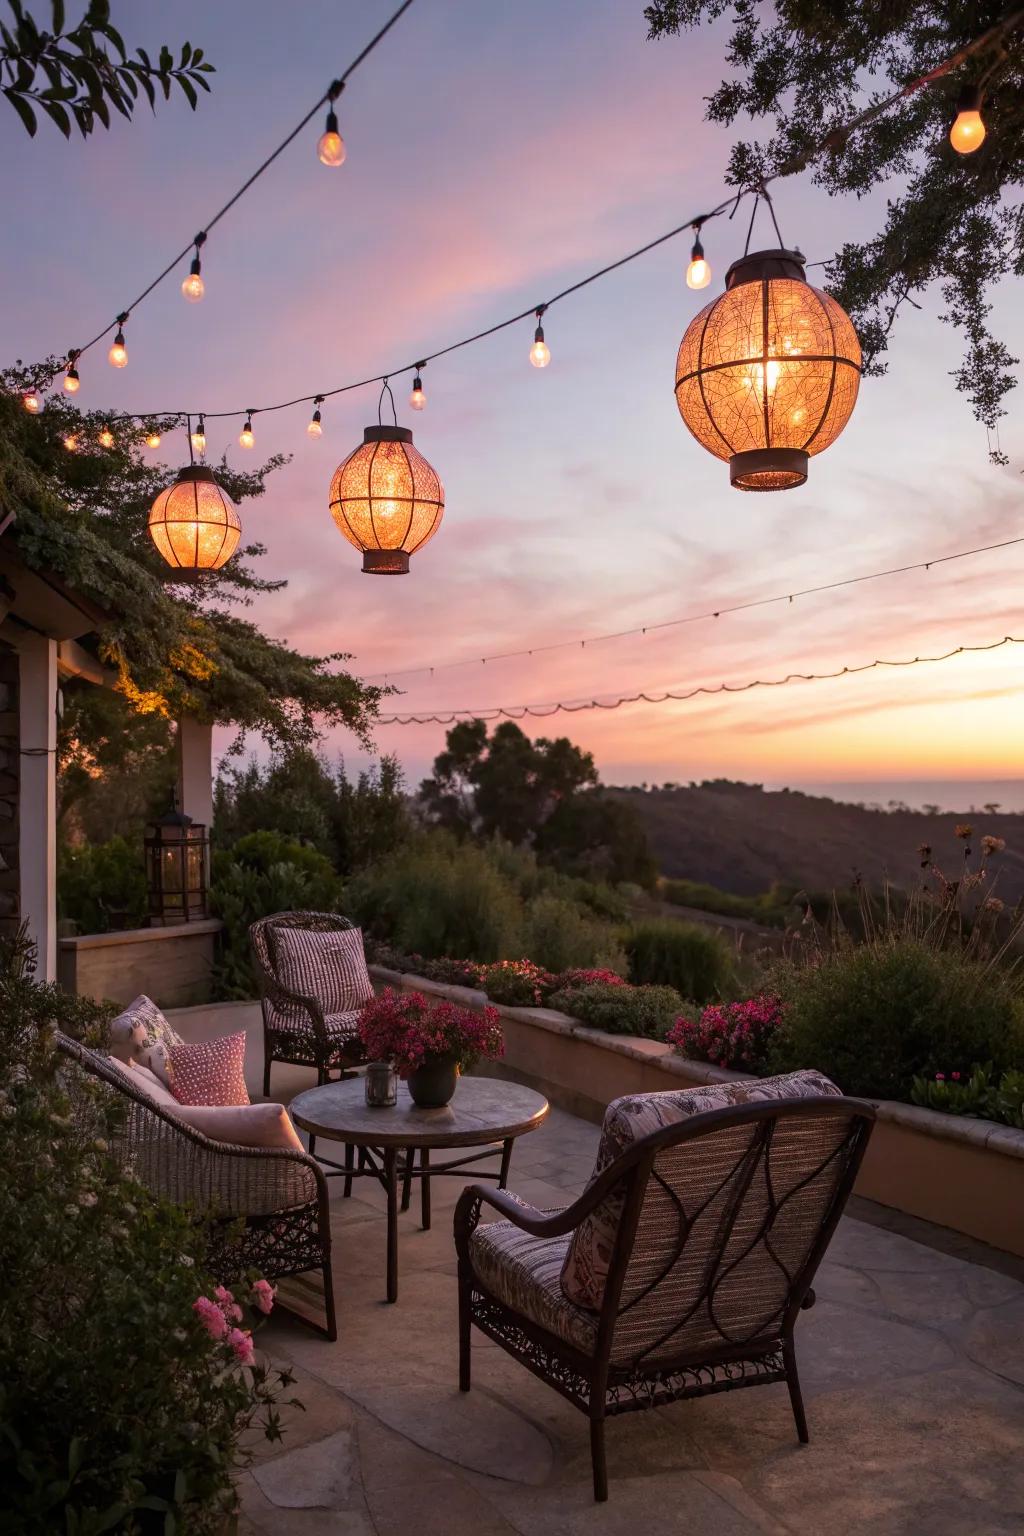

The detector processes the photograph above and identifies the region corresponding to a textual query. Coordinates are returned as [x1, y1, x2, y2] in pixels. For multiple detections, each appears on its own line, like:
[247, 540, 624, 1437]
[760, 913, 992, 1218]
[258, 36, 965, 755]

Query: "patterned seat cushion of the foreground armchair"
[470, 1221, 597, 1355]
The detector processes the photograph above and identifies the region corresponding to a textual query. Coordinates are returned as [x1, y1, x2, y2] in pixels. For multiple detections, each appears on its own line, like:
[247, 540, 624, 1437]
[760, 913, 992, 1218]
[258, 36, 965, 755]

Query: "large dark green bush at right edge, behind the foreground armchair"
[769, 937, 1024, 1098]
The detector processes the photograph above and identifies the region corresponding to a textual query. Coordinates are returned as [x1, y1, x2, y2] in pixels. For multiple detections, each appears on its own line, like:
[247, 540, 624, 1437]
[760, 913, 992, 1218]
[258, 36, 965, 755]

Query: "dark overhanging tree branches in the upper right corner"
[645, 0, 1024, 462]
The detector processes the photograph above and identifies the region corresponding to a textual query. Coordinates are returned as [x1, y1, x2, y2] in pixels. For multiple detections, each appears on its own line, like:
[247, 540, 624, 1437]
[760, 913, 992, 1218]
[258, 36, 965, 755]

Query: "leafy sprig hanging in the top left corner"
[0, 0, 213, 138]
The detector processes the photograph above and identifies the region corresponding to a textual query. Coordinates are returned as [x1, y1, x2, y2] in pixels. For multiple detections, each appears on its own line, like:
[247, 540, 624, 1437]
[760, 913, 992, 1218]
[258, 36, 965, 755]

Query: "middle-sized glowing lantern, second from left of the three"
[330, 427, 444, 576]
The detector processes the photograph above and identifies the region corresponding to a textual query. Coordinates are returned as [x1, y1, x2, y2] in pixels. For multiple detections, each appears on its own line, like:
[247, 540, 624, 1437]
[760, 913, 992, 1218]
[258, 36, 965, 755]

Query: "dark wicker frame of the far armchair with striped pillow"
[249, 912, 368, 1095]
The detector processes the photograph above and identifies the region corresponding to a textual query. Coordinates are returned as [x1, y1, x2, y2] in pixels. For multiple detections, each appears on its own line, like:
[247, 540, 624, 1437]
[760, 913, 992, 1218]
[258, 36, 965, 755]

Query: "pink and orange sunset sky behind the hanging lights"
[0, 0, 1024, 785]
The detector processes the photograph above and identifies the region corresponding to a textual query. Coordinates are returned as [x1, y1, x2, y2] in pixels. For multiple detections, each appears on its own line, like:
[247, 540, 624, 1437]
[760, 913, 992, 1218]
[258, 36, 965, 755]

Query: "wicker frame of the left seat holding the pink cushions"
[57, 1035, 338, 1339]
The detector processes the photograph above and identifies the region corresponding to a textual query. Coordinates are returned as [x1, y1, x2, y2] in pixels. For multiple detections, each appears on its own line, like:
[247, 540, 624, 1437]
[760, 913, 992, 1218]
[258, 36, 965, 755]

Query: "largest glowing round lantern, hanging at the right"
[676, 250, 861, 490]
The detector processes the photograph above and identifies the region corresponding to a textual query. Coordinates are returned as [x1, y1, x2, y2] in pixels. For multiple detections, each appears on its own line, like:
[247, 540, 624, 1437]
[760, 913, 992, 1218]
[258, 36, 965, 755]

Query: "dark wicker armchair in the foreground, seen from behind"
[454, 1098, 875, 1499]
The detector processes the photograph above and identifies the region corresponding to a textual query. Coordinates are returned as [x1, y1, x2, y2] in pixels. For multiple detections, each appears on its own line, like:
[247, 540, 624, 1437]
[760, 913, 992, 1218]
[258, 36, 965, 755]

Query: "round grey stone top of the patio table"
[290, 1077, 548, 1147]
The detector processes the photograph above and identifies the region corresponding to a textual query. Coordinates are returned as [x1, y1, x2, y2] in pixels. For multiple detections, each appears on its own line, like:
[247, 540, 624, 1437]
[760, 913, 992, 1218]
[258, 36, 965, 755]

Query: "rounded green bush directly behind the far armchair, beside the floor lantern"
[210, 833, 342, 998]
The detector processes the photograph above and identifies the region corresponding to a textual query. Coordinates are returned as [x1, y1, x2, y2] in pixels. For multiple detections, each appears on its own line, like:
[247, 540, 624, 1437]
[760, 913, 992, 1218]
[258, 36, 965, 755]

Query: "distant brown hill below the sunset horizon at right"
[608, 780, 1024, 903]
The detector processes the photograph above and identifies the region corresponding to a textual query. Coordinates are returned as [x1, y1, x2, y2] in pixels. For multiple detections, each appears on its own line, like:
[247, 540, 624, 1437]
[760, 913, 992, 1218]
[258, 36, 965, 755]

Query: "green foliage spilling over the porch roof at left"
[0, 359, 382, 750]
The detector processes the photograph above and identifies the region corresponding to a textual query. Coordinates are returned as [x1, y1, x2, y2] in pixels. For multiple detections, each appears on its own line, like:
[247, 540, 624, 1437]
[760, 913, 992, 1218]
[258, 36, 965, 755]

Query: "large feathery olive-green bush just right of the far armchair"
[347, 833, 522, 962]
